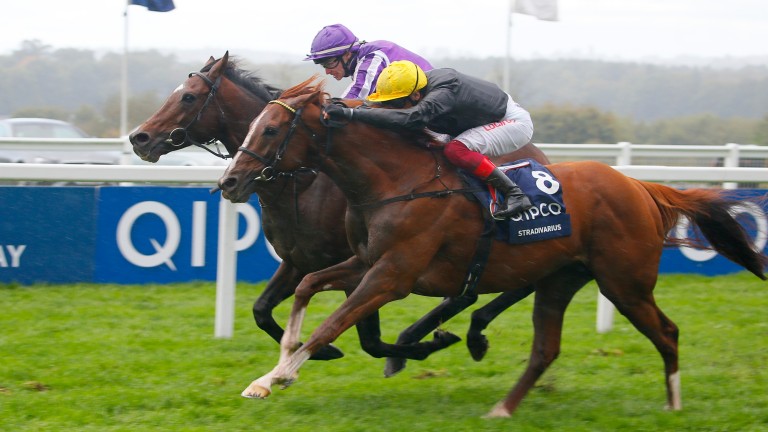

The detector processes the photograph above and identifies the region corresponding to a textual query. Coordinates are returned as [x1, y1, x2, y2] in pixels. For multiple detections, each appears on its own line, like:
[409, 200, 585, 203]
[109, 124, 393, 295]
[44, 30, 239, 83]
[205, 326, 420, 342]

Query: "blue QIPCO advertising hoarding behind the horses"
[0, 186, 768, 284]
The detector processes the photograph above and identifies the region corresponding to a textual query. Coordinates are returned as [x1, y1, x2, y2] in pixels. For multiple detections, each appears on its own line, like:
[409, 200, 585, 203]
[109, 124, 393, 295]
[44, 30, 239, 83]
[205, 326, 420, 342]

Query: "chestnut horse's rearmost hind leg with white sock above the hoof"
[598, 273, 682, 410]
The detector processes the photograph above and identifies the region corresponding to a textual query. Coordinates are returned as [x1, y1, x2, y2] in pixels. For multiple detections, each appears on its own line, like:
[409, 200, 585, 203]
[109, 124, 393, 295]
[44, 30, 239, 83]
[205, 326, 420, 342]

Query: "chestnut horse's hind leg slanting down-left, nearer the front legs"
[487, 272, 591, 417]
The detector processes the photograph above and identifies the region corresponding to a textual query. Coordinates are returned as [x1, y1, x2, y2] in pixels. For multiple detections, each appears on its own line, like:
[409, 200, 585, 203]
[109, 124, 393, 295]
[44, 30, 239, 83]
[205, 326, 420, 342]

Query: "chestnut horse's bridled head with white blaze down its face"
[219, 76, 328, 202]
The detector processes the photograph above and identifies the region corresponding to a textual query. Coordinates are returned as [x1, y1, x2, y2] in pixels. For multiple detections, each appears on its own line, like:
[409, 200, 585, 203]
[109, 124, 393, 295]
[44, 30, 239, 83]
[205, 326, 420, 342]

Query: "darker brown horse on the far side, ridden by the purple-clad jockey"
[130, 53, 547, 376]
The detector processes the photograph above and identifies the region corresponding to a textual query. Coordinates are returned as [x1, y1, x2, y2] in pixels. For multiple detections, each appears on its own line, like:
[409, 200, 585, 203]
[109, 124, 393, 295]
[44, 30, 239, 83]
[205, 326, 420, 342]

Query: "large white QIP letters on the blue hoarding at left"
[116, 201, 274, 271]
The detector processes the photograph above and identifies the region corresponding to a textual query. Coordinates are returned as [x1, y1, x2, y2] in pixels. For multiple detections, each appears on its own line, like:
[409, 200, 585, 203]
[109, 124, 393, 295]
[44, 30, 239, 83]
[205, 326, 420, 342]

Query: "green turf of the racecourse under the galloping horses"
[0, 274, 768, 432]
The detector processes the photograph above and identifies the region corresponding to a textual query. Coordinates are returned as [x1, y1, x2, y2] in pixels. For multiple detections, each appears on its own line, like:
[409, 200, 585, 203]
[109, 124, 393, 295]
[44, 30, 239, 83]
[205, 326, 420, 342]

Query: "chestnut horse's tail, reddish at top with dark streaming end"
[640, 181, 768, 280]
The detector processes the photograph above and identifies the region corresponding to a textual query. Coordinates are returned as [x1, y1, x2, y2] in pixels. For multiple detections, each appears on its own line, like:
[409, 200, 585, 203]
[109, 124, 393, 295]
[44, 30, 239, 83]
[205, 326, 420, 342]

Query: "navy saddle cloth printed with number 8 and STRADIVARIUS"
[465, 159, 571, 244]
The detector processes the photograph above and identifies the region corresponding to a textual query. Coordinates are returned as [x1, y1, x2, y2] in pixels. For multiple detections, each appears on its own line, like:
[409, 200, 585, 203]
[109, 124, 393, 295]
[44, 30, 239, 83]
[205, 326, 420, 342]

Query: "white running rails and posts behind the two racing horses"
[0, 138, 768, 337]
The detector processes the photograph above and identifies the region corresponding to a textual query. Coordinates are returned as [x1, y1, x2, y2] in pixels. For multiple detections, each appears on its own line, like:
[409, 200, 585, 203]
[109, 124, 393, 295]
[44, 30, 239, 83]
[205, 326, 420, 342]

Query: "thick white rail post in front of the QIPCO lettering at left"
[214, 197, 239, 338]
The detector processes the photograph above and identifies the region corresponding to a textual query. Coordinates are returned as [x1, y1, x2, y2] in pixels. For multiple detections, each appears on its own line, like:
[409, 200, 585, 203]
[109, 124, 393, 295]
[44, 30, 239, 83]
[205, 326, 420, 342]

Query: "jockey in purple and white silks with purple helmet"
[304, 24, 432, 99]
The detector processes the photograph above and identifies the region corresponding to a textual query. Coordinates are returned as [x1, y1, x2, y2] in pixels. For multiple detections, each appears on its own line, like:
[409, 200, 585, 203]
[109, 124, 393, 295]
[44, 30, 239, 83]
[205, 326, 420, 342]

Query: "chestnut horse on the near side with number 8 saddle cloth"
[219, 79, 768, 416]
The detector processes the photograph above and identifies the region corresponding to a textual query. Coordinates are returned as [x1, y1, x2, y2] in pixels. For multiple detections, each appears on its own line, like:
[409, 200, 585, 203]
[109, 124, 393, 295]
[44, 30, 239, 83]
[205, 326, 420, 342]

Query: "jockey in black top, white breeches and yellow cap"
[325, 61, 533, 219]
